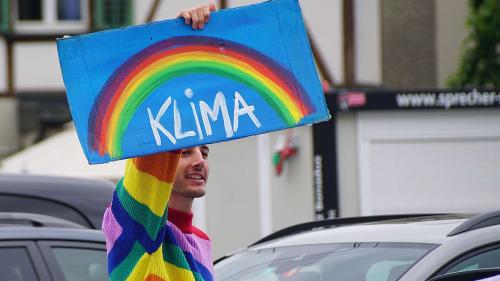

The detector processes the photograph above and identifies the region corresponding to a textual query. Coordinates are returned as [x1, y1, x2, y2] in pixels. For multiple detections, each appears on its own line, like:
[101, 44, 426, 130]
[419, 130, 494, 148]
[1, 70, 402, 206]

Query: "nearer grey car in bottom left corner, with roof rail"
[0, 213, 108, 281]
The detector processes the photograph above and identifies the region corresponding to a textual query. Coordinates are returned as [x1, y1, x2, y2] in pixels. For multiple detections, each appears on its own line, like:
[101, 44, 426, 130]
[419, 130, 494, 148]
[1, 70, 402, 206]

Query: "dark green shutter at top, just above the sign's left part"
[94, 0, 132, 29]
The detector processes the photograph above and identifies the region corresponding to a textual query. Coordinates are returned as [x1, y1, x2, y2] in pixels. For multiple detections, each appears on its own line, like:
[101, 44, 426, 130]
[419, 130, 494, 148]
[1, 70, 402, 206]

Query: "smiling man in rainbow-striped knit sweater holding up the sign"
[102, 3, 215, 281]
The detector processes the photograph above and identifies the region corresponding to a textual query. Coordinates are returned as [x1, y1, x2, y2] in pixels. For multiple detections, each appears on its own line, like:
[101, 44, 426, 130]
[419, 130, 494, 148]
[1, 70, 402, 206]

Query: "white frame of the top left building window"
[11, 0, 92, 34]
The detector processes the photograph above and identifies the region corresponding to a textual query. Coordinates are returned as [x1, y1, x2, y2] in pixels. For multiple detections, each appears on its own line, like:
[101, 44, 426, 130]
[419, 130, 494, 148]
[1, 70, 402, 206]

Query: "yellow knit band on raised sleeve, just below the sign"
[123, 160, 172, 217]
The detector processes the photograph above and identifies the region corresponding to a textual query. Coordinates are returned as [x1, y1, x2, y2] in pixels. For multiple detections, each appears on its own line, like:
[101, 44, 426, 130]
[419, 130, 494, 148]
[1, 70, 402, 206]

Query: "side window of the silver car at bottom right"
[445, 246, 500, 273]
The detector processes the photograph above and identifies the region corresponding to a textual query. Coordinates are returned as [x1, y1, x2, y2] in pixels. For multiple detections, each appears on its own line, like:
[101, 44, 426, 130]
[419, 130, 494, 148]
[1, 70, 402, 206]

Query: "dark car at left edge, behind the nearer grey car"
[0, 174, 114, 229]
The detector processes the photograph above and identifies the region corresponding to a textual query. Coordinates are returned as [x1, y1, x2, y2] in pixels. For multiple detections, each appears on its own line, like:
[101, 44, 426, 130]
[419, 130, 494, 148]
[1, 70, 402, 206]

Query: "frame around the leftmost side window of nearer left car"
[0, 240, 52, 281]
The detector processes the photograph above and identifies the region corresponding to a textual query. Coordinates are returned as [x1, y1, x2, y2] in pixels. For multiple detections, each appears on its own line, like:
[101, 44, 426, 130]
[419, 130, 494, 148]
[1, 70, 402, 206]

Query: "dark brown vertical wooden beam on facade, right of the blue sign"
[342, 0, 356, 87]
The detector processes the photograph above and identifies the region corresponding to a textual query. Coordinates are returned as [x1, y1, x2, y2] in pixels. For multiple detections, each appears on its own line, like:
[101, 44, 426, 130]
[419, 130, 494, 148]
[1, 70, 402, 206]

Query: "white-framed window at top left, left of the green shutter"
[13, 0, 90, 33]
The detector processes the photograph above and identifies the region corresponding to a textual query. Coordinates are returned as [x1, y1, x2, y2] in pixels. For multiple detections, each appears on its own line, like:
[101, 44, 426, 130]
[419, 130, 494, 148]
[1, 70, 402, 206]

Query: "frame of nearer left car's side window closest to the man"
[38, 240, 106, 281]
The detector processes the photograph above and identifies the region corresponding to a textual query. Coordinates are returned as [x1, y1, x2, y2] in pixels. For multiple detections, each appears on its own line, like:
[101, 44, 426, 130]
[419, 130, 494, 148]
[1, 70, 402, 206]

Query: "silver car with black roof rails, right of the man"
[214, 211, 500, 281]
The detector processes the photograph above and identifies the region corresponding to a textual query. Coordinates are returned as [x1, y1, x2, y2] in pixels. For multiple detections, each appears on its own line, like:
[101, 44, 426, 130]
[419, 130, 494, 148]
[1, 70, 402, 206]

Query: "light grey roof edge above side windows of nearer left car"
[0, 226, 105, 243]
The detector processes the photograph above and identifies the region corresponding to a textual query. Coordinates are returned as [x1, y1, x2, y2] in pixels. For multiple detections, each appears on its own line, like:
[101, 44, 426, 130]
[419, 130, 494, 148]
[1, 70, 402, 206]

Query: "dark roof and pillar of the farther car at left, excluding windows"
[0, 174, 114, 229]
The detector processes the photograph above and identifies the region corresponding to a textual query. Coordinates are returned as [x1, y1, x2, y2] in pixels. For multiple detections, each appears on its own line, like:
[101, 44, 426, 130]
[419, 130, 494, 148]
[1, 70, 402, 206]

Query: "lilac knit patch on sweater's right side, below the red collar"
[168, 221, 213, 275]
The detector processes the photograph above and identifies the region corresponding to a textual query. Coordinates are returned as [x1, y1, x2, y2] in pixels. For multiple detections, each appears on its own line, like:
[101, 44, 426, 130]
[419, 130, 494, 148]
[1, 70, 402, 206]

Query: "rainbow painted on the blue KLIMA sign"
[88, 36, 313, 158]
